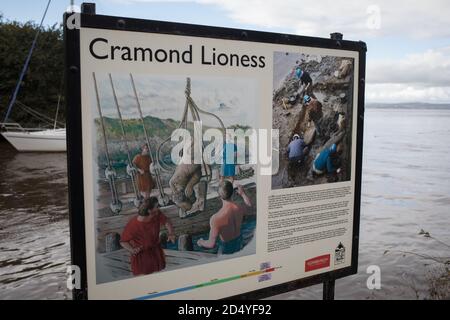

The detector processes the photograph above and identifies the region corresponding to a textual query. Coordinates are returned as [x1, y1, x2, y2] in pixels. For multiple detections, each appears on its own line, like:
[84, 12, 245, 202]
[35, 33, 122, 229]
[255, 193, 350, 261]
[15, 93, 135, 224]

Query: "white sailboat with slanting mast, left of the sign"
[0, 0, 66, 152]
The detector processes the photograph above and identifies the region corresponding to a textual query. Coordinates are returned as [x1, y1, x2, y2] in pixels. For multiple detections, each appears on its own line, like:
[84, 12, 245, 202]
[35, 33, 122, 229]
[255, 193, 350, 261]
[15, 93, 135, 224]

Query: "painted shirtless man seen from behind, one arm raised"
[197, 180, 252, 254]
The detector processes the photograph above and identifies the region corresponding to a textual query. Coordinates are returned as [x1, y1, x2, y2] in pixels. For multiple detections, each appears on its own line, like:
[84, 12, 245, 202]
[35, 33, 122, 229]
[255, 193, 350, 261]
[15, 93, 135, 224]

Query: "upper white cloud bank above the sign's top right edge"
[115, 0, 450, 39]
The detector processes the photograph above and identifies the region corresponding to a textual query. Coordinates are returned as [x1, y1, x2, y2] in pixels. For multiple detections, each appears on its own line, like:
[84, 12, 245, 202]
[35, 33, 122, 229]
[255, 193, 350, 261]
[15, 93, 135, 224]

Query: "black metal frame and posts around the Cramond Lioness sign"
[64, 3, 367, 299]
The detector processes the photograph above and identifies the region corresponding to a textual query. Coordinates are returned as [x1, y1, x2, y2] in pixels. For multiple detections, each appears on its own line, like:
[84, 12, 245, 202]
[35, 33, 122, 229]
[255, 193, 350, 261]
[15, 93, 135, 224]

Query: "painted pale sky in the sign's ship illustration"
[92, 74, 258, 128]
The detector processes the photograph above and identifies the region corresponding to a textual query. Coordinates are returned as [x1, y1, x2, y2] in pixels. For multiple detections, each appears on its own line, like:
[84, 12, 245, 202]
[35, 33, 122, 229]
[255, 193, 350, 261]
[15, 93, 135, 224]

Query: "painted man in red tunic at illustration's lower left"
[120, 197, 175, 276]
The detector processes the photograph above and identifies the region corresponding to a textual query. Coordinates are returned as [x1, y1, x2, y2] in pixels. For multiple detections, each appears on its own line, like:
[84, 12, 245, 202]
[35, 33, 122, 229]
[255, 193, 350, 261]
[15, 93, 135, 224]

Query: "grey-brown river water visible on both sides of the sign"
[0, 109, 450, 299]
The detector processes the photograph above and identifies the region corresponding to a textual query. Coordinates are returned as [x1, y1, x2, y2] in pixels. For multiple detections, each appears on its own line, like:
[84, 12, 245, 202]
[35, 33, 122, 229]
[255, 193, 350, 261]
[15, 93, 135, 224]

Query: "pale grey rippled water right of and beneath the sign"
[276, 109, 450, 299]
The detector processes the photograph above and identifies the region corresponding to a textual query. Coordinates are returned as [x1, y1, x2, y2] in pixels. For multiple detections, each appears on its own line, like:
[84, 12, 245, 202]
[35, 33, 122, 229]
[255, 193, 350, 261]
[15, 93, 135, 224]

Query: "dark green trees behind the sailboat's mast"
[0, 15, 65, 126]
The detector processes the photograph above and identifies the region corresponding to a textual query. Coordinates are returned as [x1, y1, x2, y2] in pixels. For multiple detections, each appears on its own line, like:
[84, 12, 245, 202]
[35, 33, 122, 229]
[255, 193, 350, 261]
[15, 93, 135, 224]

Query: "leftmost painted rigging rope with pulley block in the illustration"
[92, 72, 122, 214]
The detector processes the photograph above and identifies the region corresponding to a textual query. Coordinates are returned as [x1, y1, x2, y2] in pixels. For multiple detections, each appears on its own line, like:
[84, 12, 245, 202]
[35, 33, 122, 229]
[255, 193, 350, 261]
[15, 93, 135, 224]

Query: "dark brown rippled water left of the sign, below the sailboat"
[0, 146, 71, 299]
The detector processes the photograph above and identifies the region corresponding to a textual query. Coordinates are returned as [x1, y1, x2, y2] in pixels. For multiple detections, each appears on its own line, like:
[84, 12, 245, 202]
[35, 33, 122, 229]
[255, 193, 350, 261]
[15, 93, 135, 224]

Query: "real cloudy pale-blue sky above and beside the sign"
[0, 0, 450, 103]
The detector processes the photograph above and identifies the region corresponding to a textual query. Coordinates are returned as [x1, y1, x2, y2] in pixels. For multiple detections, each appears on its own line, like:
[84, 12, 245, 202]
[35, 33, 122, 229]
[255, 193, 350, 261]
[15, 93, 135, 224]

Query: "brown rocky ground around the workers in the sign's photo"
[272, 53, 354, 189]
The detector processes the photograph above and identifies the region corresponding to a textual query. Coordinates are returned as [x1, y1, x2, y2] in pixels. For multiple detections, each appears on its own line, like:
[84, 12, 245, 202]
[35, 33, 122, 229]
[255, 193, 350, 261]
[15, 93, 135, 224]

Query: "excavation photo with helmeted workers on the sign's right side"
[272, 52, 354, 189]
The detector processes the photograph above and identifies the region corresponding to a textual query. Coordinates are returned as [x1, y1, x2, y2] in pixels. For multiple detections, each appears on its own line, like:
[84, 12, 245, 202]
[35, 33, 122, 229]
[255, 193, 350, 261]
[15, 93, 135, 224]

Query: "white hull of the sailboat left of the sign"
[2, 129, 66, 152]
